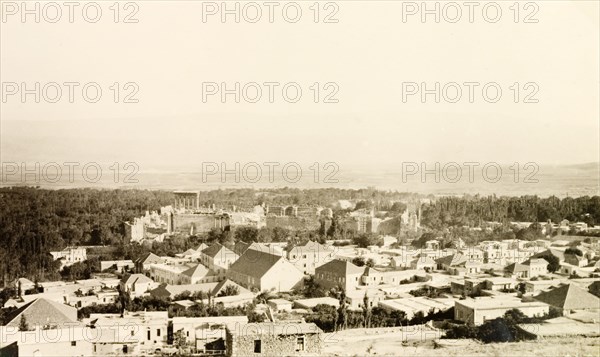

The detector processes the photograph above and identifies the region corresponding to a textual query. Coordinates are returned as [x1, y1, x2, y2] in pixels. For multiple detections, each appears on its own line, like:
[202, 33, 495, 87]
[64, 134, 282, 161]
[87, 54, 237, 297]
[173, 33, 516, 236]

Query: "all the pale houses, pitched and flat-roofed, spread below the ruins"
[5, 231, 600, 356]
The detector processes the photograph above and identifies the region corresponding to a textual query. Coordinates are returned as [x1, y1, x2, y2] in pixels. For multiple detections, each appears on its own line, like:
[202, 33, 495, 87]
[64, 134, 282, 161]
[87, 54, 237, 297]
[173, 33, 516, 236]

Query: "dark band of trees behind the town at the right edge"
[421, 196, 600, 229]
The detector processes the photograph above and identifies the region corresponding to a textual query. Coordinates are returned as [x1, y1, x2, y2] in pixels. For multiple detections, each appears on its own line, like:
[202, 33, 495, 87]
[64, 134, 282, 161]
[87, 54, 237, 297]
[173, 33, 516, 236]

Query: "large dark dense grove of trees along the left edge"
[0, 187, 172, 285]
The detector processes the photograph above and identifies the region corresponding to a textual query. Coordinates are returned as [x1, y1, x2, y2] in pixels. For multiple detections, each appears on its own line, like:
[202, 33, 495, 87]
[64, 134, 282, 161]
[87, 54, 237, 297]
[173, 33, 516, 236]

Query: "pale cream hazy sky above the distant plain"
[0, 1, 600, 170]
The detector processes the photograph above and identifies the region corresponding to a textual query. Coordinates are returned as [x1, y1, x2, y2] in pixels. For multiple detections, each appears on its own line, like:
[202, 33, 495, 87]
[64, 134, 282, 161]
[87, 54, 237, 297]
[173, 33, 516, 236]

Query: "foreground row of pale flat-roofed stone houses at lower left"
[0, 298, 323, 356]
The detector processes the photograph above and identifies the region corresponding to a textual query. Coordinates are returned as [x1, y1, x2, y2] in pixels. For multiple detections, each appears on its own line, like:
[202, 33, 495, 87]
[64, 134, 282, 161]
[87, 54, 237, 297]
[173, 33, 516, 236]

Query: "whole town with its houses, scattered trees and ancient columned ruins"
[0, 188, 600, 356]
